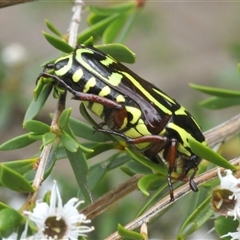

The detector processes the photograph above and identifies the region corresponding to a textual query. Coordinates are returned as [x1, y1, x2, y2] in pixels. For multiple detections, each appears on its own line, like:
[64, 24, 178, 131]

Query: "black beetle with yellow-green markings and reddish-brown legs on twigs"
[38, 45, 206, 200]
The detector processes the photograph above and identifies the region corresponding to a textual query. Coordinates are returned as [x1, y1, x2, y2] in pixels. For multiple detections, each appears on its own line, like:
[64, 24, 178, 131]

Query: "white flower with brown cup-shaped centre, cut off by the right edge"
[215, 169, 240, 220]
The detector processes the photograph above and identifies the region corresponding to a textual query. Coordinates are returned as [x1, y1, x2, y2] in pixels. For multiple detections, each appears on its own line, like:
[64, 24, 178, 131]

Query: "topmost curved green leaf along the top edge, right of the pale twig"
[89, 2, 136, 16]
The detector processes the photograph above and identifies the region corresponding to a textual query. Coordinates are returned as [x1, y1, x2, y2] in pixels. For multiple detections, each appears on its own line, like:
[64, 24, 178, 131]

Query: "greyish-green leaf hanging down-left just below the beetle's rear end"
[23, 84, 52, 122]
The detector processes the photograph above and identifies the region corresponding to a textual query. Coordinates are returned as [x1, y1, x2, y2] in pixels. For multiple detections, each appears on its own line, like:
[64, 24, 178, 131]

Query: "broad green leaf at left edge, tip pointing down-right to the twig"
[0, 164, 35, 193]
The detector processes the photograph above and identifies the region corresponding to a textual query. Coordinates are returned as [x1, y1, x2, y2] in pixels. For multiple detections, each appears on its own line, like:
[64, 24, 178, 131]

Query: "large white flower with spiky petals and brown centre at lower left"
[24, 182, 94, 240]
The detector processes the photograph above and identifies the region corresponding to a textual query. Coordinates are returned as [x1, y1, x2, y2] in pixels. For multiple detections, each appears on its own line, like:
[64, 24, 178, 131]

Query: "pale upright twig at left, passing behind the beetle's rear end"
[25, 0, 83, 207]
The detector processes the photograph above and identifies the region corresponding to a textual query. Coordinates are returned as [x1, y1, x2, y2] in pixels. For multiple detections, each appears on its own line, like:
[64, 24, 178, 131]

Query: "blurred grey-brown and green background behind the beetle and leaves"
[0, 0, 240, 239]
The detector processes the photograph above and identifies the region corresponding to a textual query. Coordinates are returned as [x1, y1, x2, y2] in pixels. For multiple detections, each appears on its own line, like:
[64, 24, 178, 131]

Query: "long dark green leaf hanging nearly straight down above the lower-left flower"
[65, 148, 92, 203]
